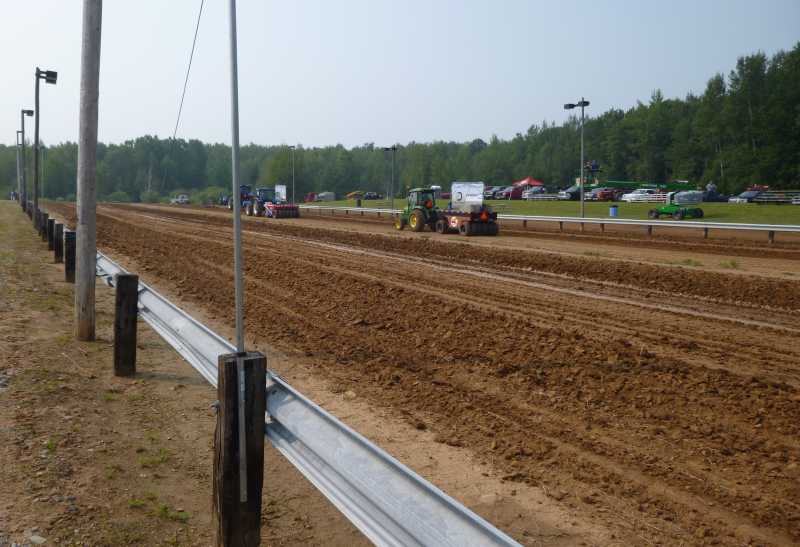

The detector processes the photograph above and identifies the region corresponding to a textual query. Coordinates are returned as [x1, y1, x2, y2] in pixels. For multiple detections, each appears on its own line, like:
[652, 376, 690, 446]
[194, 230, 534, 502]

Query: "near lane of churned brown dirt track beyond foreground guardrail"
[51, 206, 800, 545]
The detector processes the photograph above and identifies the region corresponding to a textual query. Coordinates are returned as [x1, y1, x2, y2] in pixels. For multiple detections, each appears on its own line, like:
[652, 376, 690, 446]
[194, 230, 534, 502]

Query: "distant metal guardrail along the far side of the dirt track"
[300, 205, 800, 243]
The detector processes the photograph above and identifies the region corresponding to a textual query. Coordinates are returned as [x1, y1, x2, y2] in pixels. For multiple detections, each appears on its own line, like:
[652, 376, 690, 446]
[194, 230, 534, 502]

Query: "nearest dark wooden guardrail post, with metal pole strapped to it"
[213, 352, 267, 547]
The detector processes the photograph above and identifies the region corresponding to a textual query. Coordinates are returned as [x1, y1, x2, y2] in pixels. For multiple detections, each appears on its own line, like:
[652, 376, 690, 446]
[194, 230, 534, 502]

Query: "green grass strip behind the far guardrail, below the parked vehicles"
[304, 199, 800, 224]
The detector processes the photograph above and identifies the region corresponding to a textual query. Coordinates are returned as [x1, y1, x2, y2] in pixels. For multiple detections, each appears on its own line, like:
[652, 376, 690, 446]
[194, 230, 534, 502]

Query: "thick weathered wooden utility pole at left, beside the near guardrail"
[75, 0, 103, 340]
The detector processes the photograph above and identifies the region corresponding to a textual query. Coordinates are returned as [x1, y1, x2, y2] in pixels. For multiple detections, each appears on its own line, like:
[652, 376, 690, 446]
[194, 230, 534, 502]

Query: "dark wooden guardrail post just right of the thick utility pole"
[114, 274, 139, 376]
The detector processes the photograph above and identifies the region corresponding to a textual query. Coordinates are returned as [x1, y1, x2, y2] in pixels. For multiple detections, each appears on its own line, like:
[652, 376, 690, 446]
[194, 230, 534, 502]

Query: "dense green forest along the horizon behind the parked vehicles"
[0, 43, 800, 202]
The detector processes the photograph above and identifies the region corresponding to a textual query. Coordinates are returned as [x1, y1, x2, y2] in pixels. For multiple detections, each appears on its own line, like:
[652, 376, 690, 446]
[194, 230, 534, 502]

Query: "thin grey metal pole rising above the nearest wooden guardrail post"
[229, 0, 244, 353]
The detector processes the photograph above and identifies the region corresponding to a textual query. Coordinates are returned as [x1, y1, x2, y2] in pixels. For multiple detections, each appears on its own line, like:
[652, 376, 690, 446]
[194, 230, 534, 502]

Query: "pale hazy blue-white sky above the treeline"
[0, 0, 800, 146]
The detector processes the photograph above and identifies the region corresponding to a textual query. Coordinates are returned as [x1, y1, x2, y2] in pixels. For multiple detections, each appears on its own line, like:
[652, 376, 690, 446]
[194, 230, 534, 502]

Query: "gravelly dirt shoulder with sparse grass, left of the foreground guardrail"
[0, 202, 368, 546]
